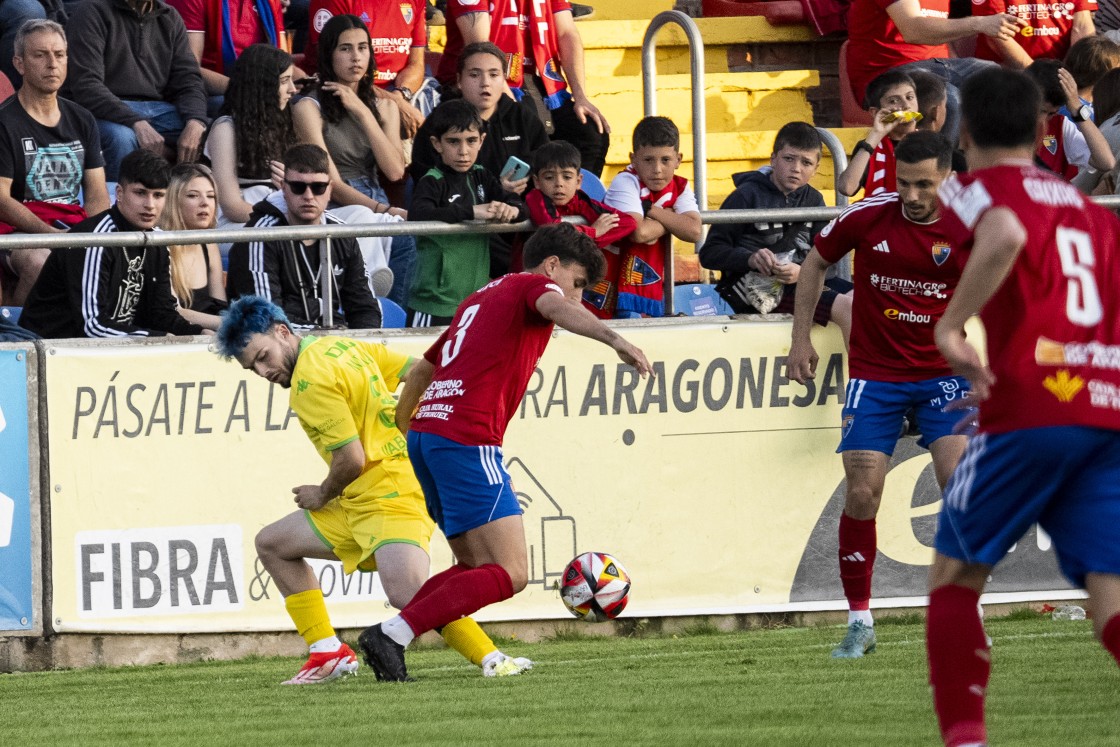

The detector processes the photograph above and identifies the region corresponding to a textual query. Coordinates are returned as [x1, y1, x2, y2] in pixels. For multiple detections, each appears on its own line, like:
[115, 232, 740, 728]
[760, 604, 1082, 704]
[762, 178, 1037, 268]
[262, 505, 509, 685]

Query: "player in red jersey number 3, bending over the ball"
[358, 224, 650, 682]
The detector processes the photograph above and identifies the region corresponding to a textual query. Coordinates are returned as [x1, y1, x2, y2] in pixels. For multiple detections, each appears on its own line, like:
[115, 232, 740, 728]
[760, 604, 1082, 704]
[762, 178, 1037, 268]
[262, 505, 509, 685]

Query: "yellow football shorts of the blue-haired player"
[305, 459, 436, 573]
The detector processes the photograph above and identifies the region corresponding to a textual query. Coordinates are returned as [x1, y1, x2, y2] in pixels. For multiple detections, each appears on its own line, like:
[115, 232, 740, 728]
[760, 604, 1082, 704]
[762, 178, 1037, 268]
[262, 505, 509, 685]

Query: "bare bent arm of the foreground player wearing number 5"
[933, 207, 1027, 401]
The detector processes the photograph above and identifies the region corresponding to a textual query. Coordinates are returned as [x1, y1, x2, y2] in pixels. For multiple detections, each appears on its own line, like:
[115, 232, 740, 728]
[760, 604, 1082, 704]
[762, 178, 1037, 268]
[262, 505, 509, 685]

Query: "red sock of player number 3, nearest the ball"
[401, 563, 513, 635]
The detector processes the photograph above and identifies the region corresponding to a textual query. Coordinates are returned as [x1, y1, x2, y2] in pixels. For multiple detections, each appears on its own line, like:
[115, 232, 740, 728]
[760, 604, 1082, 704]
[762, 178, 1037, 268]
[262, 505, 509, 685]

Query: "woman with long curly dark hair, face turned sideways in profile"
[206, 44, 296, 228]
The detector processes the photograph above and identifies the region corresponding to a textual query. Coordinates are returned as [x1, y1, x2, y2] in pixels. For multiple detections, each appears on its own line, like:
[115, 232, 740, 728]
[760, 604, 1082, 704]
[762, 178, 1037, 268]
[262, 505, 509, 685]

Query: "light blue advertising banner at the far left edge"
[0, 346, 37, 633]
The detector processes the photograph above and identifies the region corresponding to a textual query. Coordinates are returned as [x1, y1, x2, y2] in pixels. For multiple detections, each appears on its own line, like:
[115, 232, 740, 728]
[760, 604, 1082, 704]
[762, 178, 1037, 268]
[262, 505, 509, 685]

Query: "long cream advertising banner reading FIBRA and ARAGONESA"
[45, 320, 1068, 632]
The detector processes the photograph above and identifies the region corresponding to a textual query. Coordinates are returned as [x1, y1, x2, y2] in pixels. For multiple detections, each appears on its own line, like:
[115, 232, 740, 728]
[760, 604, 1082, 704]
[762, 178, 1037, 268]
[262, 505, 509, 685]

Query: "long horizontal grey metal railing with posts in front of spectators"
[8, 195, 1120, 325]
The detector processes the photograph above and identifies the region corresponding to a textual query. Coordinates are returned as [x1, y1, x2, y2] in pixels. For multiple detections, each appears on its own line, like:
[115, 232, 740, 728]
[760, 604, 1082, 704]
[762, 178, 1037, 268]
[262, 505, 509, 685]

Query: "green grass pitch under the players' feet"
[0, 614, 1120, 747]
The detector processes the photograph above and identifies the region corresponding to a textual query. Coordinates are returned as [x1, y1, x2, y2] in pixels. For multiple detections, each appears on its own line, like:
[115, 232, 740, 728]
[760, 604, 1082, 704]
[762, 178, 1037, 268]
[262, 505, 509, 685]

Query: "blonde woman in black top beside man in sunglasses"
[159, 164, 226, 330]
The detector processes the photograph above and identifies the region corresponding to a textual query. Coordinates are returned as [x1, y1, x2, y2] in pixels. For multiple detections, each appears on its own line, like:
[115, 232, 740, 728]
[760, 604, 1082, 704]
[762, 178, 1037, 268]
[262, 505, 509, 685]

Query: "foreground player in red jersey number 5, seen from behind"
[926, 69, 1120, 746]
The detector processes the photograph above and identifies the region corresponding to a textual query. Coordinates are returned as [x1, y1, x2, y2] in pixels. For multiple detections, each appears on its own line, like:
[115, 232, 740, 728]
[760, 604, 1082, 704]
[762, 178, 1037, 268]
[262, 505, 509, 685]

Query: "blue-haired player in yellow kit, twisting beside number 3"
[216, 296, 532, 684]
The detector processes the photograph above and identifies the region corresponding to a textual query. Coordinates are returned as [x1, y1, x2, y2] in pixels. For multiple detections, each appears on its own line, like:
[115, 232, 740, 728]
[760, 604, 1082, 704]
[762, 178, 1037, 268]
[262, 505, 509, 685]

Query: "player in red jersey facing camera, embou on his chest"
[788, 131, 967, 659]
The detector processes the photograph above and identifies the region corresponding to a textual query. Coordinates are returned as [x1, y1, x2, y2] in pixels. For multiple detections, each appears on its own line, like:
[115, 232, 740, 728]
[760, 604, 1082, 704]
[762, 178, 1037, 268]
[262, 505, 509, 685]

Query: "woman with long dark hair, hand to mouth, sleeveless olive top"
[292, 16, 417, 307]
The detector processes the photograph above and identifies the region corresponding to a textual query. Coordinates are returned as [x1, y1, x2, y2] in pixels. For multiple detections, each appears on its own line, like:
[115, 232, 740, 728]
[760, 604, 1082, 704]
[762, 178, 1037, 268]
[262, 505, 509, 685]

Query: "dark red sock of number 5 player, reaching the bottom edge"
[925, 586, 991, 747]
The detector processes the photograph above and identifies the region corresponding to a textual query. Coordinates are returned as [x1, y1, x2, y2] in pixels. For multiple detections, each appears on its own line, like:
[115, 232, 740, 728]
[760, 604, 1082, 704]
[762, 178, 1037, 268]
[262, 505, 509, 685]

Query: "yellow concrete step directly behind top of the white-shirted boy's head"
[589, 71, 820, 136]
